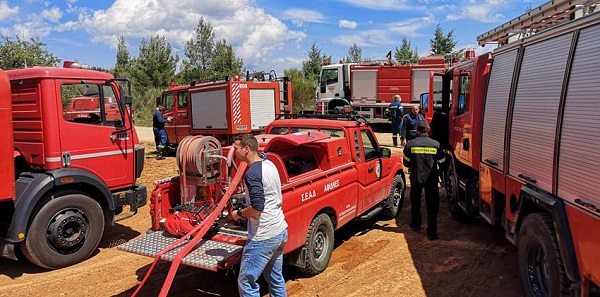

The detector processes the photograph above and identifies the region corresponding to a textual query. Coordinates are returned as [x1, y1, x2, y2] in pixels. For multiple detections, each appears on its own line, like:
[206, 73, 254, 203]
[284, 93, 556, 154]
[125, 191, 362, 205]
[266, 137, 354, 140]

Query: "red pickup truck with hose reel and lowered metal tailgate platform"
[119, 118, 404, 292]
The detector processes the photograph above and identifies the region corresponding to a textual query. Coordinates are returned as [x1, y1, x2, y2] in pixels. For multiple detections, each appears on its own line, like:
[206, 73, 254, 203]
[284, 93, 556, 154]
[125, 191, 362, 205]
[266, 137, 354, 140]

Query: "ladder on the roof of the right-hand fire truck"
[477, 0, 600, 46]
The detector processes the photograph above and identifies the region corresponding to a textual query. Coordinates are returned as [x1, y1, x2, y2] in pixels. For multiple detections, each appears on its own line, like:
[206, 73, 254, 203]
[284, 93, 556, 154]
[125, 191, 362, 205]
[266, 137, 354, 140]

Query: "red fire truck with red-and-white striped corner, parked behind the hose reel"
[159, 76, 292, 151]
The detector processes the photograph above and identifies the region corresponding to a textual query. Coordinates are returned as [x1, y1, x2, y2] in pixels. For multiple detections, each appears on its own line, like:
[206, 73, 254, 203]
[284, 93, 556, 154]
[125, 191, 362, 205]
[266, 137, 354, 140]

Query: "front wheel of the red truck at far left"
[21, 194, 104, 269]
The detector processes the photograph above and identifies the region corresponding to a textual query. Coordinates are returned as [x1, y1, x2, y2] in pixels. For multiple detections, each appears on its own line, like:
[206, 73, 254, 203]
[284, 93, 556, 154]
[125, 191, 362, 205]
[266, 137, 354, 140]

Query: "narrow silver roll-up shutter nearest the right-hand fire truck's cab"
[481, 49, 517, 170]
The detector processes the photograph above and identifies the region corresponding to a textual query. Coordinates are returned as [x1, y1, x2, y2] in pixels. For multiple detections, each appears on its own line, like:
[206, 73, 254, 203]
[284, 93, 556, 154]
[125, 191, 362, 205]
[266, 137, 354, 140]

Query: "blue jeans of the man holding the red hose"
[238, 230, 287, 297]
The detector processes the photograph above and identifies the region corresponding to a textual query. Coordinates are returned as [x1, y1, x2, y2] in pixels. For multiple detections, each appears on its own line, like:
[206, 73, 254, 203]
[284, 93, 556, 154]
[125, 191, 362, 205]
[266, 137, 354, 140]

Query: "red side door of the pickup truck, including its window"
[354, 129, 386, 213]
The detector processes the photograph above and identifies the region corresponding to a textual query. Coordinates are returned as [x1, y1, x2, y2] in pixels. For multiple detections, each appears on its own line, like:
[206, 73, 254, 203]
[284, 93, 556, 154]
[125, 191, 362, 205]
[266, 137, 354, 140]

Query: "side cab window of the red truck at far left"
[61, 83, 123, 127]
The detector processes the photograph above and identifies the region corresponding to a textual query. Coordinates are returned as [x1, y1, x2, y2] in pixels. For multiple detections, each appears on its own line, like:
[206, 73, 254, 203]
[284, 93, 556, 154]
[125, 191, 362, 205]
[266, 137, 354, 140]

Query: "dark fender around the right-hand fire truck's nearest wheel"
[513, 185, 580, 282]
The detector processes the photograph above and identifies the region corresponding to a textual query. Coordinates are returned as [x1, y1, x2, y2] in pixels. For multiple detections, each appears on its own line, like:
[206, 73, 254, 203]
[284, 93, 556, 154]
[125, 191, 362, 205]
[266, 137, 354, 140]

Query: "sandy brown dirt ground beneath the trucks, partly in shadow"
[0, 127, 523, 297]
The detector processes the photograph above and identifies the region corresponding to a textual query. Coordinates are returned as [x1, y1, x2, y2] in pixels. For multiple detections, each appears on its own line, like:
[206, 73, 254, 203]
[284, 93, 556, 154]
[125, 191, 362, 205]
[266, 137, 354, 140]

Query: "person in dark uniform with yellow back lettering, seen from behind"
[403, 120, 445, 240]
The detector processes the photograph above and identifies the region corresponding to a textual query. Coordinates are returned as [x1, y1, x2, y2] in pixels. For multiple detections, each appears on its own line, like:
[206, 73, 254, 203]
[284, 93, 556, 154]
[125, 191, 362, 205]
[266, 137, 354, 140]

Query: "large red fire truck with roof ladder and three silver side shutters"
[428, 1, 600, 296]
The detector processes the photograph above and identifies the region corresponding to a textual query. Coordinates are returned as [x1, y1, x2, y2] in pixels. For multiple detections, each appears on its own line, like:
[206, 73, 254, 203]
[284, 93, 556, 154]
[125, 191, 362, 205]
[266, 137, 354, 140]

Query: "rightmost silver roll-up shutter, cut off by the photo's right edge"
[558, 25, 600, 206]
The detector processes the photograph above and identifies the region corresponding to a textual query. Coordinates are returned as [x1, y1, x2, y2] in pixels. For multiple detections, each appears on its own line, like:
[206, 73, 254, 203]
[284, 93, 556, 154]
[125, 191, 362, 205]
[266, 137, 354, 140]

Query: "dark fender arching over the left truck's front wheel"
[6, 169, 115, 243]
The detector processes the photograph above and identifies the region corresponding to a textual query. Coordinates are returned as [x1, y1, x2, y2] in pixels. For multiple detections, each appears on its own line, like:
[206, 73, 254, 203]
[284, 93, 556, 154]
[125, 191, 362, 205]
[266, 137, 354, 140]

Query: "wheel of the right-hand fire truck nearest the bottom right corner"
[518, 213, 571, 297]
